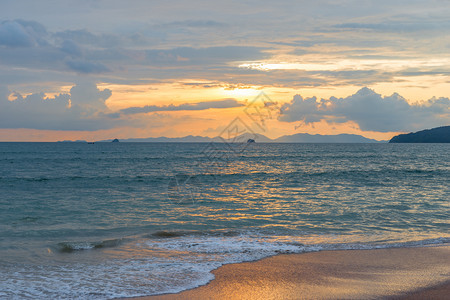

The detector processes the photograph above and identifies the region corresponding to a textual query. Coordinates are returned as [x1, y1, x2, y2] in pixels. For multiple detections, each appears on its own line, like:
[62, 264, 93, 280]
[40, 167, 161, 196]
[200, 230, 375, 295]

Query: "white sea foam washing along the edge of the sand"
[0, 233, 450, 299]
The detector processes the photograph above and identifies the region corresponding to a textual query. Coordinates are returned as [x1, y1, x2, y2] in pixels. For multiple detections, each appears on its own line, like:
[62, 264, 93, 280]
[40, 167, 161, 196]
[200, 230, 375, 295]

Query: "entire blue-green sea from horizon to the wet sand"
[0, 143, 450, 299]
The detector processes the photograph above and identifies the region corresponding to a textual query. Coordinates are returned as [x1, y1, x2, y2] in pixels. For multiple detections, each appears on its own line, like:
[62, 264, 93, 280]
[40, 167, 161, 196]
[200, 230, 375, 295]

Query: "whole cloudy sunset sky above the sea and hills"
[0, 0, 450, 141]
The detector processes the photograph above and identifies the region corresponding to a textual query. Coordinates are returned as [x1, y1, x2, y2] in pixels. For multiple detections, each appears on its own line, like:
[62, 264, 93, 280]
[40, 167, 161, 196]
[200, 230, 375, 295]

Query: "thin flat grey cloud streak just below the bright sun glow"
[121, 99, 244, 115]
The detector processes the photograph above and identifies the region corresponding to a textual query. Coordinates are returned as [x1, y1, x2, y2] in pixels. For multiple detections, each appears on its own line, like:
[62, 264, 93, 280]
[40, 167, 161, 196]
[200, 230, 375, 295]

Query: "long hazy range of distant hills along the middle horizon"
[93, 132, 387, 143]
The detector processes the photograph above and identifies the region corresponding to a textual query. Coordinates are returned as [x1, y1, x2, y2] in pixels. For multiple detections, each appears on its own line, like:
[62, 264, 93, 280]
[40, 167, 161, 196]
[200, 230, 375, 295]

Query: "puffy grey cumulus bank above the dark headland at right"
[279, 88, 450, 132]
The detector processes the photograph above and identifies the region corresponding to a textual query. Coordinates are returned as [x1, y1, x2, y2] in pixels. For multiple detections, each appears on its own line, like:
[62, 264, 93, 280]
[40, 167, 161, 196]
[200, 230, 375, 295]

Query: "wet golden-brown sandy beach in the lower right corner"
[134, 246, 450, 299]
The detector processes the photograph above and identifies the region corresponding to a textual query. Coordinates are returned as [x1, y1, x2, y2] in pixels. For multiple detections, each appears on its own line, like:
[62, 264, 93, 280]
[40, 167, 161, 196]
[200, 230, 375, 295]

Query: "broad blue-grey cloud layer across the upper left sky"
[0, 20, 270, 83]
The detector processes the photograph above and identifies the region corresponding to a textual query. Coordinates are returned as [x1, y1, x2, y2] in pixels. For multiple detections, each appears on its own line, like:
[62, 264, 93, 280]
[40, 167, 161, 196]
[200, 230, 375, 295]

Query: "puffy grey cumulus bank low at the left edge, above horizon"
[0, 83, 118, 131]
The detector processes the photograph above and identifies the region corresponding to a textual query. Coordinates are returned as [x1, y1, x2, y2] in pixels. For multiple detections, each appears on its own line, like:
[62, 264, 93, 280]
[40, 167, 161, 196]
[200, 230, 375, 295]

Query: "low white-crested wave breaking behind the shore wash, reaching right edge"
[147, 231, 450, 254]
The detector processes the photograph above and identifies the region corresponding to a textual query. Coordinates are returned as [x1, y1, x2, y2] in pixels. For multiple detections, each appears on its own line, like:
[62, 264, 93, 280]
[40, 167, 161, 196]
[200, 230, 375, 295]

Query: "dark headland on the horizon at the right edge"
[389, 126, 450, 143]
